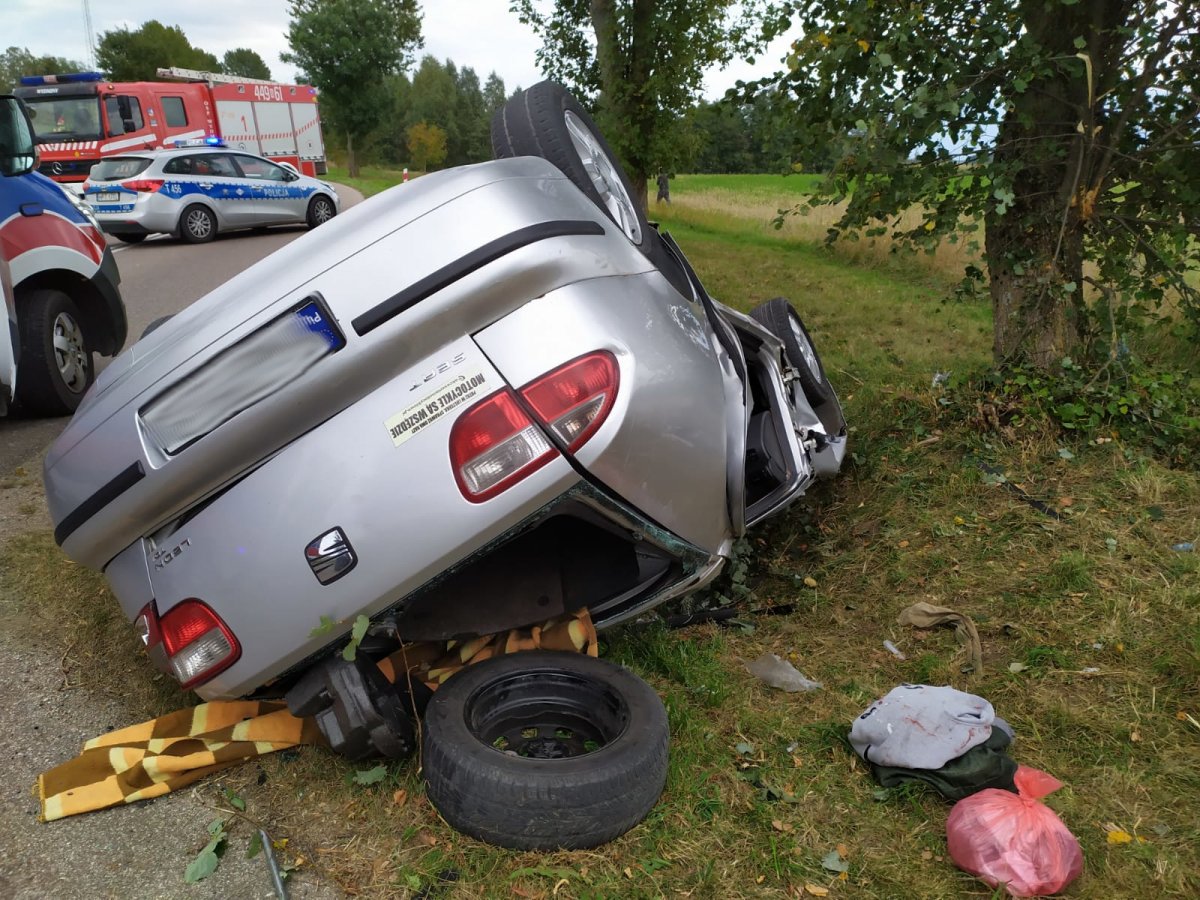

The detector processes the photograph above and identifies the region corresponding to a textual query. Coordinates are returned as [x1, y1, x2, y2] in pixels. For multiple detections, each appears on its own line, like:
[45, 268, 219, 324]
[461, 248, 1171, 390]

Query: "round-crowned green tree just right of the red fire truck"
[283, 0, 421, 176]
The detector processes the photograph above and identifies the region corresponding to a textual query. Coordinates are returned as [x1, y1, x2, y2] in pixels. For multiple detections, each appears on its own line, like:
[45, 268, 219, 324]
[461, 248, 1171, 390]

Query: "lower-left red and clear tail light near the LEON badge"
[136, 600, 241, 689]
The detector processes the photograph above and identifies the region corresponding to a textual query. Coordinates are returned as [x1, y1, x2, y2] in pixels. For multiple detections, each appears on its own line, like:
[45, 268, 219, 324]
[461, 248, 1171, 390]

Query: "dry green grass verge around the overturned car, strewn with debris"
[2, 176, 1200, 898]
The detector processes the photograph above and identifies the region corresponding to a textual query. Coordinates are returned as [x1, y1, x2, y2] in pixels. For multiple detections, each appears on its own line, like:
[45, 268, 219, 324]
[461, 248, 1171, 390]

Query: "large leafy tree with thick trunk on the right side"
[780, 0, 1200, 367]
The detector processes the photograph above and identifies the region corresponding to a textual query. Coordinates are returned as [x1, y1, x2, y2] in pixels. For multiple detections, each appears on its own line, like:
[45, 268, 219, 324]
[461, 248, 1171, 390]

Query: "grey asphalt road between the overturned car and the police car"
[0, 185, 362, 475]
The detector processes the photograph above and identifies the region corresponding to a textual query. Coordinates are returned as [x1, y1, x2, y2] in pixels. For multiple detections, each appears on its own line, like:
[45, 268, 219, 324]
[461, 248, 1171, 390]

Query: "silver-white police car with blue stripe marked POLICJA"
[83, 144, 340, 244]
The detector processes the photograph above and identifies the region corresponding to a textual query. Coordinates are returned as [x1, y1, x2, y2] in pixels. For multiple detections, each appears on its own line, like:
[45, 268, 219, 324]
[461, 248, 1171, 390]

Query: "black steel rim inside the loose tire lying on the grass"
[463, 670, 629, 760]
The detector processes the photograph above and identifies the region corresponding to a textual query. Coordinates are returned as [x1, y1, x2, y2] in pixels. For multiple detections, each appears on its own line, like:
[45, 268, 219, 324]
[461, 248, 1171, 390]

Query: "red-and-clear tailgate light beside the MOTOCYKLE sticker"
[450, 388, 558, 503]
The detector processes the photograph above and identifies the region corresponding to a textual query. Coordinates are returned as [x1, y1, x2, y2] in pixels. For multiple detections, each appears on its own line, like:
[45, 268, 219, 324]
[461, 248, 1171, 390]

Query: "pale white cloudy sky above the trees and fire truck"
[9, 0, 788, 100]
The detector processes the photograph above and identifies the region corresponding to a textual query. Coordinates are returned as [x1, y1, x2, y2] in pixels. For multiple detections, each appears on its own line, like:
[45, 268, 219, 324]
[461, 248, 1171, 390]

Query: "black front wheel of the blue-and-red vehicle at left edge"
[13, 288, 96, 416]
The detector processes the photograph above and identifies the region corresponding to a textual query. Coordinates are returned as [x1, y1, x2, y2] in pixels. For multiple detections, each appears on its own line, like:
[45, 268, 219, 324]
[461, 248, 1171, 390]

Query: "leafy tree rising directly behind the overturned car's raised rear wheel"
[511, 0, 773, 208]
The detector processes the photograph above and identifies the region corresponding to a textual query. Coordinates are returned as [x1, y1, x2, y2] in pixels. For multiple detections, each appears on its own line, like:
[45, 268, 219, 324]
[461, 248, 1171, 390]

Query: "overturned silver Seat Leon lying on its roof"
[39, 83, 846, 846]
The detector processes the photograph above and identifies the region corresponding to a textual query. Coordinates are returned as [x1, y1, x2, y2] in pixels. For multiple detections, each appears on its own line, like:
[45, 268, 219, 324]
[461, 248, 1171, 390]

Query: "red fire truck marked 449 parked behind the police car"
[13, 68, 325, 192]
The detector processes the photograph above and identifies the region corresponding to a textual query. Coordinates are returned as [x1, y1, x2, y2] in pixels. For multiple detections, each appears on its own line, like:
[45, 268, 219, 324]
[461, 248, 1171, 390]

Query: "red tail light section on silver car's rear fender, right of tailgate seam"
[521, 350, 620, 452]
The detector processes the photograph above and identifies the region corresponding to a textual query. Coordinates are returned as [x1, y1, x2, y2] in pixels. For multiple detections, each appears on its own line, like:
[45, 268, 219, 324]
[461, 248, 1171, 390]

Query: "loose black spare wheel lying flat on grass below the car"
[422, 650, 670, 850]
